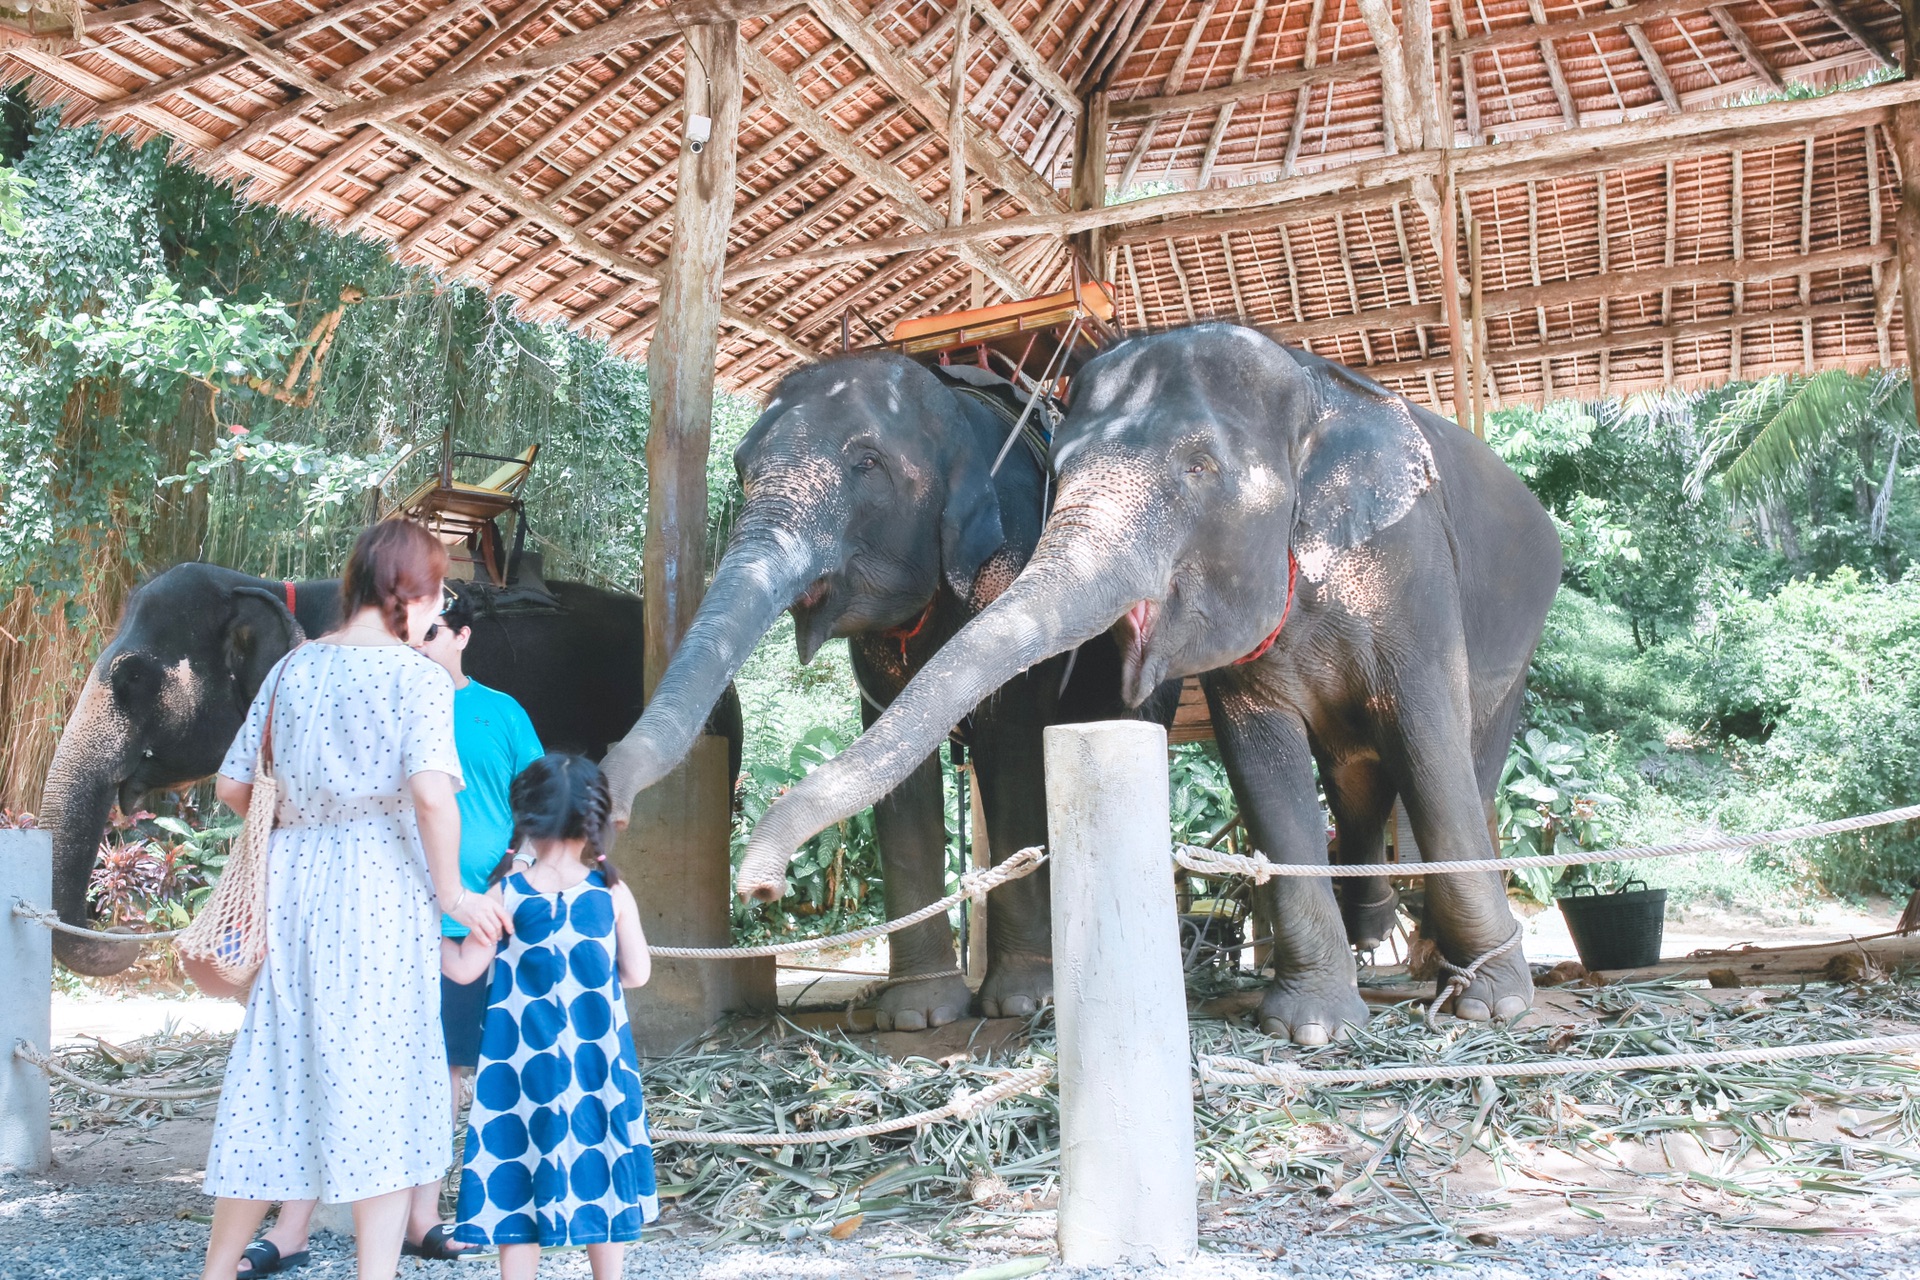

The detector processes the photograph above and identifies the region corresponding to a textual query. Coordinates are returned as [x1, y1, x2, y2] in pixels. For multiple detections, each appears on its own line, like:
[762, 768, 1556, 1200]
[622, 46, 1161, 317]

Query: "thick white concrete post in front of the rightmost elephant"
[1044, 720, 1198, 1267]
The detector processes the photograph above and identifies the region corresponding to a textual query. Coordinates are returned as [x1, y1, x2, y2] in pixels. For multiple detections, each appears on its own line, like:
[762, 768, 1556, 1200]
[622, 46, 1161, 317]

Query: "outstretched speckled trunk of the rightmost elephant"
[735, 487, 1165, 902]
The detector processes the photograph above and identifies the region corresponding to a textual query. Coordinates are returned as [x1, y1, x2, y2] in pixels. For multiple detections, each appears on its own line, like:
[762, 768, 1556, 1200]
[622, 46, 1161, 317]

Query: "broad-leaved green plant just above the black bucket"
[1494, 729, 1619, 904]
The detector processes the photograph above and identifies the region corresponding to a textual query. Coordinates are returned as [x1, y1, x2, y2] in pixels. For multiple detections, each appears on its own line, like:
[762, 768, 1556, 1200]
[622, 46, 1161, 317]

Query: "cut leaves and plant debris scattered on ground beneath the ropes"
[41, 983, 1920, 1245]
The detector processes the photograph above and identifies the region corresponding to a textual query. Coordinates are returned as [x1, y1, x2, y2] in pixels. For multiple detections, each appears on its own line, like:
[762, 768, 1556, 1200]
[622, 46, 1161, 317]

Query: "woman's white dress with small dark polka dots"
[205, 643, 461, 1203]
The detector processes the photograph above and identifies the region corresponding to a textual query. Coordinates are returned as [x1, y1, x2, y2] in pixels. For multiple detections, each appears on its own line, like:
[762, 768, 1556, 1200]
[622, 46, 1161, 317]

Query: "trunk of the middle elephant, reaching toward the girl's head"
[601, 512, 820, 821]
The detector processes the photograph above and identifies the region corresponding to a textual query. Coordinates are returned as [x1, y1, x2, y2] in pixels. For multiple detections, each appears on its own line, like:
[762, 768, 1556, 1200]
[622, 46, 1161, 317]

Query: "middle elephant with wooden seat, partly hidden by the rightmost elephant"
[603, 353, 1179, 1031]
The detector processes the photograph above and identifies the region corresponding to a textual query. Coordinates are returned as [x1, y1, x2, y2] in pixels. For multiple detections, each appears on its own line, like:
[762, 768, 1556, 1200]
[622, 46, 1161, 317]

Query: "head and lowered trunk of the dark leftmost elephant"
[40, 564, 314, 975]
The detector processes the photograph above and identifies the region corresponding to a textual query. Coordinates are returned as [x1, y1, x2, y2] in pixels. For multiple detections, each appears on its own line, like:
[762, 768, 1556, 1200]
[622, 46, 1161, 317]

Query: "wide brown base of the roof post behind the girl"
[612, 733, 774, 1057]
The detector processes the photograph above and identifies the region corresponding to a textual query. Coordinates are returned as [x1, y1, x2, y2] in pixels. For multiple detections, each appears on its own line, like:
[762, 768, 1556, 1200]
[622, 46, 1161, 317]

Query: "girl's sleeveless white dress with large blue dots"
[453, 871, 660, 1245]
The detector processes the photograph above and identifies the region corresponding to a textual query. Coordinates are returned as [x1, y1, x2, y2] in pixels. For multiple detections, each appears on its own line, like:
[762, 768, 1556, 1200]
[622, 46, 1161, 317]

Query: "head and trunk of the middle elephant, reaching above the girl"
[601, 353, 1039, 819]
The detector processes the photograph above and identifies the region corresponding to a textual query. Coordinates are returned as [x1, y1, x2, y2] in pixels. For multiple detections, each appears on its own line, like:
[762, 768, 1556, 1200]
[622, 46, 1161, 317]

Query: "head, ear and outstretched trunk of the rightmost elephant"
[737, 324, 1434, 900]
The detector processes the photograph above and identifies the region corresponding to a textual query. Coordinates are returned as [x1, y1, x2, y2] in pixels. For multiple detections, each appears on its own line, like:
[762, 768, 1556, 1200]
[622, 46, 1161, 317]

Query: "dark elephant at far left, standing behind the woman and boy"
[40, 564, 741, 975]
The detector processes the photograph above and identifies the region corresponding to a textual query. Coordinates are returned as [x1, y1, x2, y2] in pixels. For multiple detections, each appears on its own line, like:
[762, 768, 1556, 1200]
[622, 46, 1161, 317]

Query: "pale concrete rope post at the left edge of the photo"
[0, 831, 54, 1173]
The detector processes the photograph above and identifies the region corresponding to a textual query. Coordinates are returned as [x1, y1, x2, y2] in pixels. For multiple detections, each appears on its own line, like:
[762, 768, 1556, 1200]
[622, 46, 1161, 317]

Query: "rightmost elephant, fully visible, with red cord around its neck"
[739, 324, 1561, 1044]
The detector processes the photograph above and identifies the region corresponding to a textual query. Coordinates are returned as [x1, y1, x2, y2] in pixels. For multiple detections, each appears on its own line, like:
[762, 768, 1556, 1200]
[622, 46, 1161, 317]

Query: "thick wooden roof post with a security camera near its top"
[645, 23, 741, 699]
